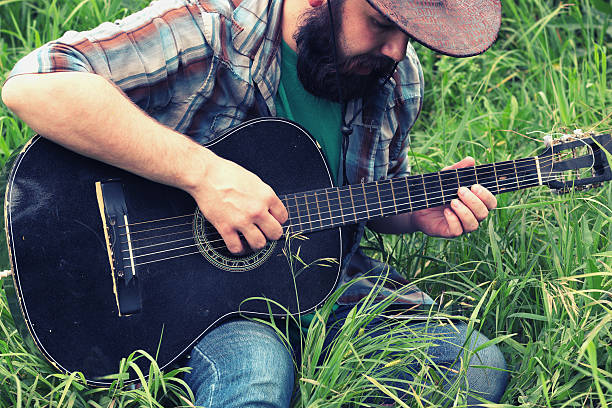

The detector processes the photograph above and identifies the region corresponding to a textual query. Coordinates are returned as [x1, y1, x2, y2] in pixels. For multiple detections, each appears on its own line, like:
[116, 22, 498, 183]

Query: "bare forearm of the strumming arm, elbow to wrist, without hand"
[2, 72, 216, 192]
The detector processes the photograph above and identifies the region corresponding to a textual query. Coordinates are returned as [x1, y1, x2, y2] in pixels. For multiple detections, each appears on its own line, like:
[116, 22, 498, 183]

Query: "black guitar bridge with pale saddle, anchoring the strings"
[96, 180, 142, 316]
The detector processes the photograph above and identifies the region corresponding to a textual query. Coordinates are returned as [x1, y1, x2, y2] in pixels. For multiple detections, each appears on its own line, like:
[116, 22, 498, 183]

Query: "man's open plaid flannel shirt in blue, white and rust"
[10, 0, 431, 303]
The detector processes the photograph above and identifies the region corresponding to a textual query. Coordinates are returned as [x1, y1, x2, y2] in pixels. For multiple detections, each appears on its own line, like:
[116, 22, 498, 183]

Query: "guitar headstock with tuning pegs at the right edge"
[538, 130, 612, 193]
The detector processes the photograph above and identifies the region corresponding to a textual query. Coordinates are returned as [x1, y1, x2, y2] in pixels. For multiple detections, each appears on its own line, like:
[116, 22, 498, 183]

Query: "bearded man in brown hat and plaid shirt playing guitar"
[2, 0, 506, 407]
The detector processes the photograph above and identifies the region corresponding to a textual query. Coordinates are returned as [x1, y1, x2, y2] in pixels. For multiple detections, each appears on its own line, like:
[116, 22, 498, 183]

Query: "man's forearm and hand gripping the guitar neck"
[368, 157, 497, 238]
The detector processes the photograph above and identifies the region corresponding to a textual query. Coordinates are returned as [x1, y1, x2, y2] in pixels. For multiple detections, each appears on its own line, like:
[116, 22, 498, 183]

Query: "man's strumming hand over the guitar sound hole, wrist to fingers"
[190, 156, 288, 254]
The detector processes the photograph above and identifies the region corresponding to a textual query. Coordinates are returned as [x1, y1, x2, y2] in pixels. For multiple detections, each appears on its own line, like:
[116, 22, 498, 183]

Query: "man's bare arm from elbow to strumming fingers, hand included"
[2, 72, 287, 253]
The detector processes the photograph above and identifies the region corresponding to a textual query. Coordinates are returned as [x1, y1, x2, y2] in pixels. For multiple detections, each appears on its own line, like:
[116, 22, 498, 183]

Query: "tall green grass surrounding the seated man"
[0, 0, 612, 408]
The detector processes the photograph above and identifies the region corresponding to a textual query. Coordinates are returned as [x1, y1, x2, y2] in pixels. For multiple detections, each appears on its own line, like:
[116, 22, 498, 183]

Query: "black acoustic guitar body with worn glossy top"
[5, 118, 342, 385]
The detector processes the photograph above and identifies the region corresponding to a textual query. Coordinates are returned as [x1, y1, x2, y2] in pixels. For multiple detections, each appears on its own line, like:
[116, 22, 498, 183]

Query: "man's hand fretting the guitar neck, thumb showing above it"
[411, 157, 497, 238]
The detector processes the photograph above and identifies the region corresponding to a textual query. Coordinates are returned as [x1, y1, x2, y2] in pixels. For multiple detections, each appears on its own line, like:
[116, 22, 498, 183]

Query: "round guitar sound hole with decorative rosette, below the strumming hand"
[193, 209, 276, 272]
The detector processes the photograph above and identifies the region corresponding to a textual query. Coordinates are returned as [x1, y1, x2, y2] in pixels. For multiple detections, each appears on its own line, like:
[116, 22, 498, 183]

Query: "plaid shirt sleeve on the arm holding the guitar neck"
[383, 44, 424, 178]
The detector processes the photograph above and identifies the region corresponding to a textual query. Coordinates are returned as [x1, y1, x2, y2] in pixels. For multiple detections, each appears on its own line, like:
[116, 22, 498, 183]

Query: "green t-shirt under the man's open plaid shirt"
[274, 41, 342, 184]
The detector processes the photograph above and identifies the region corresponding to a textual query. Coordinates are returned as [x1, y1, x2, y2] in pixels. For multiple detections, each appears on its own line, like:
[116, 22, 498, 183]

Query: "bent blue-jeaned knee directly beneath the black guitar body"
[185, 320, 294, 408]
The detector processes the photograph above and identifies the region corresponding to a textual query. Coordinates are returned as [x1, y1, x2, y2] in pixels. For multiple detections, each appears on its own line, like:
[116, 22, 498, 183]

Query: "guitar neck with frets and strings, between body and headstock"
[281, 157, 542, 234]
